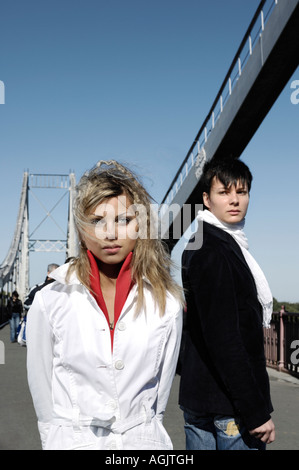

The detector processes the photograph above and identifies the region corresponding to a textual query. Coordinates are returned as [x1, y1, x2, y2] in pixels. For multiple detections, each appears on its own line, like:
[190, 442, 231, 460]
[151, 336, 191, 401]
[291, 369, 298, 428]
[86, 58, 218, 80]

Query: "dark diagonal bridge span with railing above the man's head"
[160, 0, 299, 250]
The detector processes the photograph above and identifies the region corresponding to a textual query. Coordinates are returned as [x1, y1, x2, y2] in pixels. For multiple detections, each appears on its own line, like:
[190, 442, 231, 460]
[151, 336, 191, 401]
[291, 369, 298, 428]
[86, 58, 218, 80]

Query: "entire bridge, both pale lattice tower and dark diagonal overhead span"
[0, 0, 299, 316]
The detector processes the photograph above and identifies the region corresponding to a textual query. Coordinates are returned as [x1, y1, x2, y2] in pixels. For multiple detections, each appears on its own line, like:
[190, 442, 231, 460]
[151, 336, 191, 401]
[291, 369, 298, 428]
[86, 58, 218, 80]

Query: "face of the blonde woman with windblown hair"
[83, 194, 138, 264]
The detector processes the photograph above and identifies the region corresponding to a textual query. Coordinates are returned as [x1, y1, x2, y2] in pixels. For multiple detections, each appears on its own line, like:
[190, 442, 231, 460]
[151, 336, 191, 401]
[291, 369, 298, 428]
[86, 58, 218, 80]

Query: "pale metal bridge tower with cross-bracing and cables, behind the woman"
[0, 172, 78, 325]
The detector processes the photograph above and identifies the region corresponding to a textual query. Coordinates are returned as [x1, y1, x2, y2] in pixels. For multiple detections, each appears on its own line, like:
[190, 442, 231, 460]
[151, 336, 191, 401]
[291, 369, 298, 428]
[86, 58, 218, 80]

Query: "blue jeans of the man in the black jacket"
[184, 410, 266, 450]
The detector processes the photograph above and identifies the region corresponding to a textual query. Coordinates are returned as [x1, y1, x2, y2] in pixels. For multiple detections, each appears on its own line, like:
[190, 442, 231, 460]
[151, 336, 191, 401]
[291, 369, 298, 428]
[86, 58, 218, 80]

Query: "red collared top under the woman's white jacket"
[87, 250, 134, 347]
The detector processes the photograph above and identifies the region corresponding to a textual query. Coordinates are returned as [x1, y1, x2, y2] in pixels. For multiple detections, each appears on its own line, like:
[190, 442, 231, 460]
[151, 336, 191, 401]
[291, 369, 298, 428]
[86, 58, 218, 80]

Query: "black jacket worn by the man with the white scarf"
[179, 222, 273, 430]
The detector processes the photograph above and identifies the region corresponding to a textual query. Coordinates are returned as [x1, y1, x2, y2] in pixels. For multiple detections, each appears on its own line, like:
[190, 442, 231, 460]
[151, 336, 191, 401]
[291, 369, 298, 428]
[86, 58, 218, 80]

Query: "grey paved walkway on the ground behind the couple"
[0, 326, 299, 450]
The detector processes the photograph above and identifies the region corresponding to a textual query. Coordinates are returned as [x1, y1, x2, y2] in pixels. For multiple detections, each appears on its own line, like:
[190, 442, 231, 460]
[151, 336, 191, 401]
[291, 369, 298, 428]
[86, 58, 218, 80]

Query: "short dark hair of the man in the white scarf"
[200, 158, 253, 194]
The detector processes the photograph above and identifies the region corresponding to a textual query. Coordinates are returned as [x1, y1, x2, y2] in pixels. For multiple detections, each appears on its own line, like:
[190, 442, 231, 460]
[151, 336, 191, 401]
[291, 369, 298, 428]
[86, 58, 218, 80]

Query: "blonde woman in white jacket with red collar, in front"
[27, 161, 182, 450]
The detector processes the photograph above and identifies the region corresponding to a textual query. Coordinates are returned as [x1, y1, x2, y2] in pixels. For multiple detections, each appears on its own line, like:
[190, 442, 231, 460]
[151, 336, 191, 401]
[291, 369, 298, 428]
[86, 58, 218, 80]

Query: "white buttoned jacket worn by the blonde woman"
[26, 265, 182, 450]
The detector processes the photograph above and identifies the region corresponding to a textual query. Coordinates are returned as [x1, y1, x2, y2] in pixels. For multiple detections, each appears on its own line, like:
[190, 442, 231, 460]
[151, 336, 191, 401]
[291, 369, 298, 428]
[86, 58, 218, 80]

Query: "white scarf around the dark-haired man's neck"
[197, 210, 273, 328]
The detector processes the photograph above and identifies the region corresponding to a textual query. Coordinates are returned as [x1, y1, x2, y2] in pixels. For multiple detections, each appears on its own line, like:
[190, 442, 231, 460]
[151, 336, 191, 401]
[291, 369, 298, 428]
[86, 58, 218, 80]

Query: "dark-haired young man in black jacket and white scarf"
[179, 159, 275, 450]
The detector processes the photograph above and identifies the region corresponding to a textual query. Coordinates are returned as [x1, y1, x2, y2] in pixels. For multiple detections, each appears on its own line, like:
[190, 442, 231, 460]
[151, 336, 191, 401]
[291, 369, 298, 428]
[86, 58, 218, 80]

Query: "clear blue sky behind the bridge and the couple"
[0, 0, 299, 302]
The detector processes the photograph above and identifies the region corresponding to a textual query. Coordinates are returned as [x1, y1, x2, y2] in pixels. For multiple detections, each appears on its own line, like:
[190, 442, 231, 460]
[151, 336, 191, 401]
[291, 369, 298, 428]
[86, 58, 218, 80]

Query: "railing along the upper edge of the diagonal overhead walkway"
[161, 0, 279, 207]
